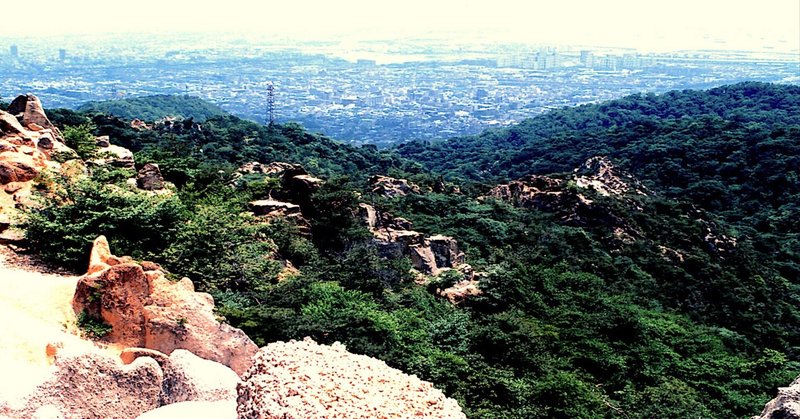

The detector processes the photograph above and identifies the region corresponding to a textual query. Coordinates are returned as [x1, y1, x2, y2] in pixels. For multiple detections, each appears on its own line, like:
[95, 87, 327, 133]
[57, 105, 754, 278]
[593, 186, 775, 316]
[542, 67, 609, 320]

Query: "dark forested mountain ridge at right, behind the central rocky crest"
[397, 82, 800, 232]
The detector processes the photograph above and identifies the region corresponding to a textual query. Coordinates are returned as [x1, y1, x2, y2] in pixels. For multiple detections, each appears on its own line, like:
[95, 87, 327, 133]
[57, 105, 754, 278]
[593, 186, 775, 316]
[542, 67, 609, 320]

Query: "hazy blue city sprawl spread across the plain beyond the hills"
[0, 35, 800, 144]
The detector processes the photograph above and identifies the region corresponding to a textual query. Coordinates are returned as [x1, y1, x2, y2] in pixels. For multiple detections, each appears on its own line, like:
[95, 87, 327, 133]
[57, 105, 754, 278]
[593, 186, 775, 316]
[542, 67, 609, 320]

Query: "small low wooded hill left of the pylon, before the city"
[78, 95, 227, 122]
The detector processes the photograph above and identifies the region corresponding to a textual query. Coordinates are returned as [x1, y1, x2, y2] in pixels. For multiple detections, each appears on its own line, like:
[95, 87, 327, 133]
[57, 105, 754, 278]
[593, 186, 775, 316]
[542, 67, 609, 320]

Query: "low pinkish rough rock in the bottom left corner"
[0, 353, 163, 419]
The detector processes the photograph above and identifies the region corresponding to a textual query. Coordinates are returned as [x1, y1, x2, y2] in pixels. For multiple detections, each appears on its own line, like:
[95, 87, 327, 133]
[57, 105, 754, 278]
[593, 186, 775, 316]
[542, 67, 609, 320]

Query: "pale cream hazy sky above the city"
[0, 0, 800, 53]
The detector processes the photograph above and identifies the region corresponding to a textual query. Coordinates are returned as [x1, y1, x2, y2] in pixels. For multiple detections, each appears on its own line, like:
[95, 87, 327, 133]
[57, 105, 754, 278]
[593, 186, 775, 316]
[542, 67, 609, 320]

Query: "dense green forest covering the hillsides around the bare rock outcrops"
[15, 83, 800, 418]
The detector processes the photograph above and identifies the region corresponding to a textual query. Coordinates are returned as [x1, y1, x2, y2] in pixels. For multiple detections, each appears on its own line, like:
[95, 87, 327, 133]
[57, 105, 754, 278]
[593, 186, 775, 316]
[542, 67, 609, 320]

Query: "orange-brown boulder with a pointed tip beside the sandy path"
[73, 236, 258, 374]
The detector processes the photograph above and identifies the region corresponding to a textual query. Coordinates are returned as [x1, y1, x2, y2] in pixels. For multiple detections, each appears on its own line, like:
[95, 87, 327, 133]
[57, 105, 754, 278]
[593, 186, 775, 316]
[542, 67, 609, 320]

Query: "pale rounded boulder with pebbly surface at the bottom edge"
[237, 338, 466, 419]
